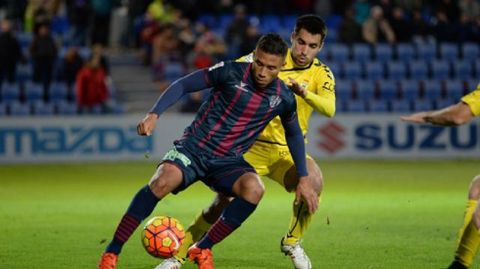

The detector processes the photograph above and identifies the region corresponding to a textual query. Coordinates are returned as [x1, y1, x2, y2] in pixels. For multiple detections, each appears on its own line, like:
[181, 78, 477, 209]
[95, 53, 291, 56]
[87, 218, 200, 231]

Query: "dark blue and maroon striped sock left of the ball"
[106, 185, 160, 255]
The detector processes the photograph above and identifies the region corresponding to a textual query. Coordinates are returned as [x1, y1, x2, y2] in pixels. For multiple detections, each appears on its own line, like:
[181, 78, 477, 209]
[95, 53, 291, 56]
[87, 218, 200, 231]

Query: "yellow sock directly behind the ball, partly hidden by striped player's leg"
[175, 210, 212, 263]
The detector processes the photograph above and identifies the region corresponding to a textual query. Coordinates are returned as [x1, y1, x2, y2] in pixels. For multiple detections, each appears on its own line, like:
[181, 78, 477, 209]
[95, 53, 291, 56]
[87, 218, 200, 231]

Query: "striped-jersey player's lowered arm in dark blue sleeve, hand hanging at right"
[282, 112, 318, 213]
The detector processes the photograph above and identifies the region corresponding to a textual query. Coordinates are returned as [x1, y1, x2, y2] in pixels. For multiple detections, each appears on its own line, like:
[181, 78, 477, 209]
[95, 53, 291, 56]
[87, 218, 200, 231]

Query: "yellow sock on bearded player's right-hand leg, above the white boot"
[283, 201, 312, 245]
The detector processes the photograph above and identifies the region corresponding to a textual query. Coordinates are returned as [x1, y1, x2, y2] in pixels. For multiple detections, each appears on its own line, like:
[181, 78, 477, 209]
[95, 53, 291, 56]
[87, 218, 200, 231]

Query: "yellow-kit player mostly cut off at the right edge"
[402, 84, 480, 269]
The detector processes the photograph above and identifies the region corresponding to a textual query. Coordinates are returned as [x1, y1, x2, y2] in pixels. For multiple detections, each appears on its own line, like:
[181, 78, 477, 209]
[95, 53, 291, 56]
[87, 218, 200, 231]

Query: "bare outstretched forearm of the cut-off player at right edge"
[400, 102, 474, 126]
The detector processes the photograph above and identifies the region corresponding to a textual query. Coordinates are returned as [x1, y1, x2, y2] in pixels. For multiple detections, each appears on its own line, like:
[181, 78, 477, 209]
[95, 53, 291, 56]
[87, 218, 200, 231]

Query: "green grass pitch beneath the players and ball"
[0, 160, 480, 269]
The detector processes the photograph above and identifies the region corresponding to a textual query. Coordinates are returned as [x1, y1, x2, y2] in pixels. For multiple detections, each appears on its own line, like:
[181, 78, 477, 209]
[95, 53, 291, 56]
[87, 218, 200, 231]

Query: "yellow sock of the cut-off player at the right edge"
[455, 200, 480, 267]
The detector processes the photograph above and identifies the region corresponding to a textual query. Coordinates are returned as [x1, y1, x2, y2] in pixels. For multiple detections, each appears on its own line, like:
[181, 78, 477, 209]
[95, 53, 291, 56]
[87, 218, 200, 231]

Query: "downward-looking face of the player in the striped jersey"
[253, 49, 285, 88]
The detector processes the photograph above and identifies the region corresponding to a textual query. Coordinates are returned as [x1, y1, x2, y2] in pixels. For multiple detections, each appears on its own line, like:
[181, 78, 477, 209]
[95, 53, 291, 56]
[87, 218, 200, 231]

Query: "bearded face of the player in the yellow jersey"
[291, 29, 323, 67]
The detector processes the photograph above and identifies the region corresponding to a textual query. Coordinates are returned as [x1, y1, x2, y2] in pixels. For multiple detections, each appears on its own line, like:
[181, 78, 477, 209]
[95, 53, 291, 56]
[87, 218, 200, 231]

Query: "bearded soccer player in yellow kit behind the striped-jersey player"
[156, 15, 335, 269]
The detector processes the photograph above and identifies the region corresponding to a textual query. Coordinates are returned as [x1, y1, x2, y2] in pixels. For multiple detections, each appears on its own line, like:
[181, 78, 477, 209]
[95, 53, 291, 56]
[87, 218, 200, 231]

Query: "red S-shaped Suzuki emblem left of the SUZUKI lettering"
[317, 121, 345, 154]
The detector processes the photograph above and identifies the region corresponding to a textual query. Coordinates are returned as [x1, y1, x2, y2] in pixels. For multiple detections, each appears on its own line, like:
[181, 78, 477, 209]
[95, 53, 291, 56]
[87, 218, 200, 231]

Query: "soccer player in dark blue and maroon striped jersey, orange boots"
[99, 34, 316, 269]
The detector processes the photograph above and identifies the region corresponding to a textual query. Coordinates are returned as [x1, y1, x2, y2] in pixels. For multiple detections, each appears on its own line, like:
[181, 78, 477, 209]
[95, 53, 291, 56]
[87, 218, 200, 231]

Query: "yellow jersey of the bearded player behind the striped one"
[237, 49, 335, 145]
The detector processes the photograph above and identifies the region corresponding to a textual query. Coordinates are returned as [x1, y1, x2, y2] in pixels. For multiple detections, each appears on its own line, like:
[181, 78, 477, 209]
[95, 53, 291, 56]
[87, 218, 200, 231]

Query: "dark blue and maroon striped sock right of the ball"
[197, 197, 257, 249]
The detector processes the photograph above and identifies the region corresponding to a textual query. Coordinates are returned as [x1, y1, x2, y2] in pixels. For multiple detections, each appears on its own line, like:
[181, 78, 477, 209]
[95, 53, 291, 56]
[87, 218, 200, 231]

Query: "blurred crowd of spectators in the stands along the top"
[0, 0, 480, 114]
